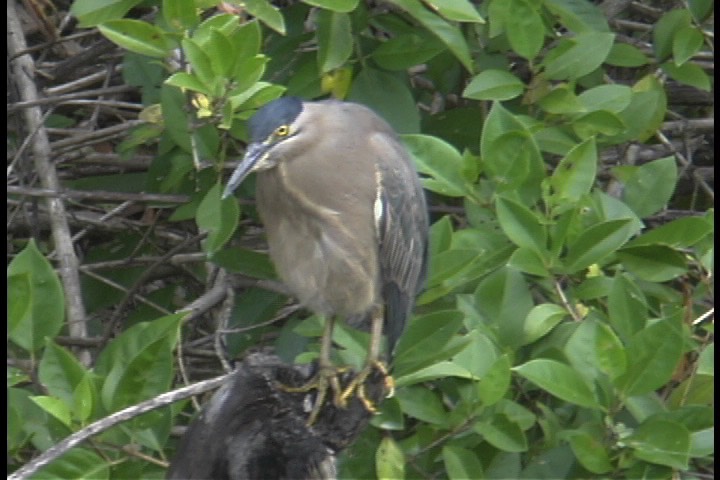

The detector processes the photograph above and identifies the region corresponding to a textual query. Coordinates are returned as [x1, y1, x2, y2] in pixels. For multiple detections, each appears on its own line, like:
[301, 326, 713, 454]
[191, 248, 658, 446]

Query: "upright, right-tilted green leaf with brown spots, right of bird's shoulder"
[550, 138, 597, 204]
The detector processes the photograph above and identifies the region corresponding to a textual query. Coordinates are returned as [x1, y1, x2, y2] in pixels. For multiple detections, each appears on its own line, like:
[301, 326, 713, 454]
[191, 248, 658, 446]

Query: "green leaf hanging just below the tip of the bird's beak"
[196, 183, 240, 256]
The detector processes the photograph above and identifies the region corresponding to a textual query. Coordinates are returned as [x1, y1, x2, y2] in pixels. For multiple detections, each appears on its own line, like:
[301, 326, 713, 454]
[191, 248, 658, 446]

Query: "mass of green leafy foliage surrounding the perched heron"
[8, 0, 714, 479]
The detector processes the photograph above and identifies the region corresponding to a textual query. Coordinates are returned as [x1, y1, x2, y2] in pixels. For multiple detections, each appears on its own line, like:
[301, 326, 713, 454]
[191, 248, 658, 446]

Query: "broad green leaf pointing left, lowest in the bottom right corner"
[623, 419, 690, 470]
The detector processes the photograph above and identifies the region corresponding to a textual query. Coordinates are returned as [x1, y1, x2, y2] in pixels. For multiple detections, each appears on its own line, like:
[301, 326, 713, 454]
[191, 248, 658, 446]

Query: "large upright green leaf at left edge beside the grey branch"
[7, 239, 65, 352]
